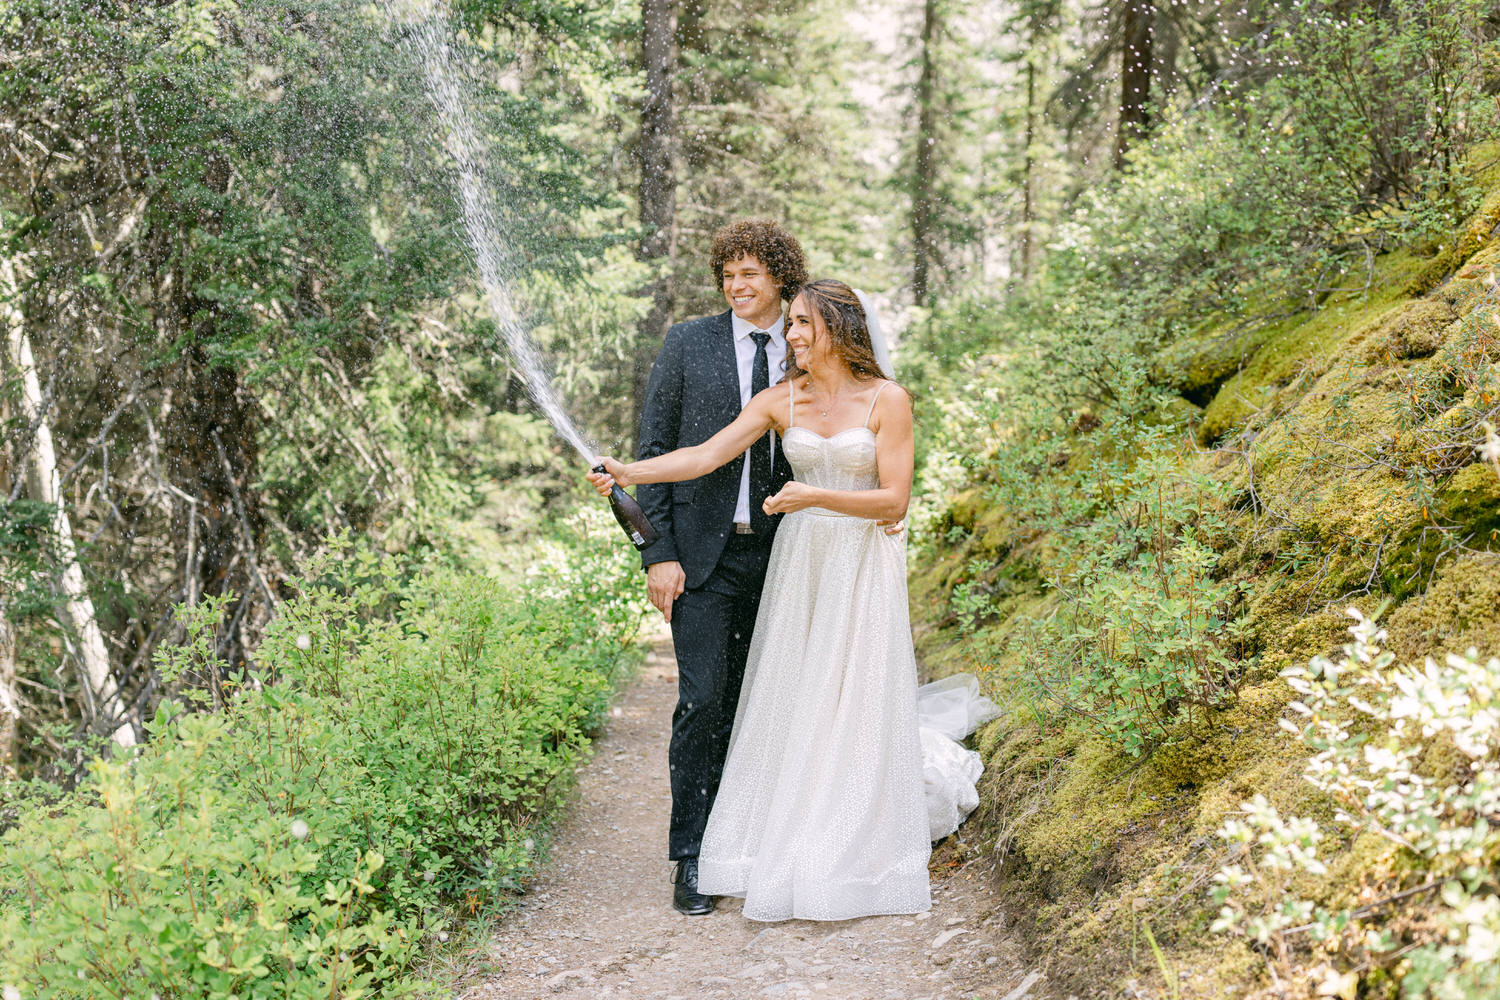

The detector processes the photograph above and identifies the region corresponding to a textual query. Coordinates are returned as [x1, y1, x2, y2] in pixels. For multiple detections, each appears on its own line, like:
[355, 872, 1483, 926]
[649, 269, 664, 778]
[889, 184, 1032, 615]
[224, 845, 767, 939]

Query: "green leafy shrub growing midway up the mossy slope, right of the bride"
[1017, 432, 1244, 756]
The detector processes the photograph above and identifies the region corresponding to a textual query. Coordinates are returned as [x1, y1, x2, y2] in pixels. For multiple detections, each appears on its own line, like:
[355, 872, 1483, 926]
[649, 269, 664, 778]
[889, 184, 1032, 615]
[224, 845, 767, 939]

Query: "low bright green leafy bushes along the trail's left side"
[0, 527, 632, 997]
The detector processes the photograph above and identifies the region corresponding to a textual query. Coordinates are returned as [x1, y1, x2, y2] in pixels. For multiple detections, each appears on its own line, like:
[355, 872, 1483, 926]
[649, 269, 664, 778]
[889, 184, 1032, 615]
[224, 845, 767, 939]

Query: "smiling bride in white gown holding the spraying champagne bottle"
[590, 279, 932, 921]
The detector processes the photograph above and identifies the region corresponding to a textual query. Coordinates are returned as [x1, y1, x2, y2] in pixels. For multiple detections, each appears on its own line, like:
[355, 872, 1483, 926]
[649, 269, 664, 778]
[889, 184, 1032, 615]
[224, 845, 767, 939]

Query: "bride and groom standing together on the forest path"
[590, 219, 954, 921]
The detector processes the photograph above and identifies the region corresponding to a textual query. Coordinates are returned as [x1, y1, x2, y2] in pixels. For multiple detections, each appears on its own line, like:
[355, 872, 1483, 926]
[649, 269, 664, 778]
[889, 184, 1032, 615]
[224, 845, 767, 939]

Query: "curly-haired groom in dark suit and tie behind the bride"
[636, 219, 807, 916]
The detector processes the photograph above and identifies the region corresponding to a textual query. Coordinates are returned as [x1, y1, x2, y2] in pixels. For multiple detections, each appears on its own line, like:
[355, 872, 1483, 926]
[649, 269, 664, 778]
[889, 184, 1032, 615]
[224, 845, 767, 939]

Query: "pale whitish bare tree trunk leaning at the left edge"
[0, 259, 135, 747]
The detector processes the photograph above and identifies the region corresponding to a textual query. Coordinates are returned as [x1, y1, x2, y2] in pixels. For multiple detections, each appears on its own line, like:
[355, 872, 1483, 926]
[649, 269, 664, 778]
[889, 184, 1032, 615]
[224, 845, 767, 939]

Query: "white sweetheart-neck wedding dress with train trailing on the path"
[698, 383, 993, 921]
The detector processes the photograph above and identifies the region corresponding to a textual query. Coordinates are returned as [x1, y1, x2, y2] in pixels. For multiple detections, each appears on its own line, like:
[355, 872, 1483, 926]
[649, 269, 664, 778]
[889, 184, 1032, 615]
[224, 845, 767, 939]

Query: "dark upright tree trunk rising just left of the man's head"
[632, 0, 677, 426]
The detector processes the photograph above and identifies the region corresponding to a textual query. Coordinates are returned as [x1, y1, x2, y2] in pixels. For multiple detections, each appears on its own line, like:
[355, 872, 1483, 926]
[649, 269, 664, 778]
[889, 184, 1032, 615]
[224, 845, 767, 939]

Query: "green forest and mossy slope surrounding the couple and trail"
[0, 0, 1500, 1000]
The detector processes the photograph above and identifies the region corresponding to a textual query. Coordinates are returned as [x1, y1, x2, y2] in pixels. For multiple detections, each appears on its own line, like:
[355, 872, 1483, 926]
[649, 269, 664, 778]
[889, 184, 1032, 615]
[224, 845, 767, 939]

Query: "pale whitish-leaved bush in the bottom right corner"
[1214, 609, 1500, 1000]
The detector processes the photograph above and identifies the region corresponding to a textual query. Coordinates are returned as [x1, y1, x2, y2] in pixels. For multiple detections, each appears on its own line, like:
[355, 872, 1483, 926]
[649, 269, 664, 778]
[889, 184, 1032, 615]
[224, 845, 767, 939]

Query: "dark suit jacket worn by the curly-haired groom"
[636, 312, 792, 588]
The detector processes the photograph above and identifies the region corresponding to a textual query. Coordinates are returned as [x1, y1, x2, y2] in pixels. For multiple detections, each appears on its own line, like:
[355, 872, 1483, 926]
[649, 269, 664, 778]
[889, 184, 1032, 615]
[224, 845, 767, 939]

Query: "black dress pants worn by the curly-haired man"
[668, 534, 771, 861]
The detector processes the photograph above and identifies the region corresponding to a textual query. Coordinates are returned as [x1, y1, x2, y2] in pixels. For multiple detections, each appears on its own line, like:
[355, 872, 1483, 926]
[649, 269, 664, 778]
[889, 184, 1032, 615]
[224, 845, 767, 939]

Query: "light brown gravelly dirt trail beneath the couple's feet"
[462, 639, 1046, 1000]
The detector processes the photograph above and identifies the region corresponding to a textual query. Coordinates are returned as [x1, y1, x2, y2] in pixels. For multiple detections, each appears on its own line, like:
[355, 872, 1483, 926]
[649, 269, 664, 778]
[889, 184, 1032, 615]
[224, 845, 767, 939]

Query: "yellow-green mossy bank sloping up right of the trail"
[914, 153, 1500, 997]
